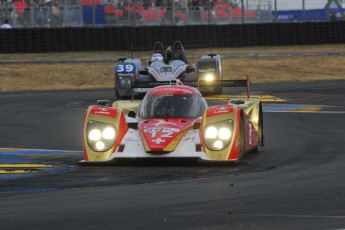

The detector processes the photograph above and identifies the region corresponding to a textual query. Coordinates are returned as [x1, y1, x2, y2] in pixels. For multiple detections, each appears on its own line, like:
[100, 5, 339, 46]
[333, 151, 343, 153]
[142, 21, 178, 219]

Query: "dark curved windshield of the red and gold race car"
[139, 94, 206, 119]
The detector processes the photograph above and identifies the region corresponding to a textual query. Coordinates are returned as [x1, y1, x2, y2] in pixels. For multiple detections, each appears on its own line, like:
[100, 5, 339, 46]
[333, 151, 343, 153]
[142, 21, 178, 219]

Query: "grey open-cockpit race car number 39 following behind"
[115, 41, 222, 99]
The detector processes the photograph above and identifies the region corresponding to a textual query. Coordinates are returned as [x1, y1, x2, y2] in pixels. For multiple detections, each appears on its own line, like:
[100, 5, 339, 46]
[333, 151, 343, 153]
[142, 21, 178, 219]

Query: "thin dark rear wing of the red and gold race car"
[132, 76, 250, 98]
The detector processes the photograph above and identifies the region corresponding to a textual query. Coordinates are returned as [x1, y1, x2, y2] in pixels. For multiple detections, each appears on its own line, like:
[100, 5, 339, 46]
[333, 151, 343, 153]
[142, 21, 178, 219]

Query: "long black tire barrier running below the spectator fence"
[0, 21, 345, 53]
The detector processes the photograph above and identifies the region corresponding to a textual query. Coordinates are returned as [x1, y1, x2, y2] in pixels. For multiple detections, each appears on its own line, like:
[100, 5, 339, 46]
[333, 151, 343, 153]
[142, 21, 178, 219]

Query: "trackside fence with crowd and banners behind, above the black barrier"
[0, 0, 345, 28]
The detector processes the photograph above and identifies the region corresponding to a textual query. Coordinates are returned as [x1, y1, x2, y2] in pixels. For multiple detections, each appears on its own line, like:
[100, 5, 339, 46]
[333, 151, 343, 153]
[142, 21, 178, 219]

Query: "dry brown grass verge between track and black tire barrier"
[0, 45, 345, 92]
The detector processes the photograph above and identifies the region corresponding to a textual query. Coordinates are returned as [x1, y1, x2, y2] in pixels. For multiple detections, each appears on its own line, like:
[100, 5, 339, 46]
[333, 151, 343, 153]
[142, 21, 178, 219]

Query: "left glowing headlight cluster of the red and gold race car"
[86, 121, 117, 152]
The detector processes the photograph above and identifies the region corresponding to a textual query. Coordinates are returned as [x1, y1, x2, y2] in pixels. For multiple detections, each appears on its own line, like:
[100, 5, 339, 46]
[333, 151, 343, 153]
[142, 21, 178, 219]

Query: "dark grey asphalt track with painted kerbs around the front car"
[0, 81, 345, 230]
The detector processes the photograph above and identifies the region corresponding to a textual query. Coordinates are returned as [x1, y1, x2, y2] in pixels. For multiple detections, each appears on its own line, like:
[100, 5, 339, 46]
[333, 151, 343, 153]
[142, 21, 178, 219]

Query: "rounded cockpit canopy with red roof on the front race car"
[138, 86, 207, 119]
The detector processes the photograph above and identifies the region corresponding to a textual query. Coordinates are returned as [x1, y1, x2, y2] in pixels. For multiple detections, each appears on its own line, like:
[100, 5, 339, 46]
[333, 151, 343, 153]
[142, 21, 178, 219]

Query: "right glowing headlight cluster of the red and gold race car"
[204, 121, 232, 151]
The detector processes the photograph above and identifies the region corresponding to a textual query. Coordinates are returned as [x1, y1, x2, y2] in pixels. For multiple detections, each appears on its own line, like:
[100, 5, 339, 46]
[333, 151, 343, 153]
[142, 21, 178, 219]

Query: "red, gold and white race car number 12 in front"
[80, 80, 264, 164]
